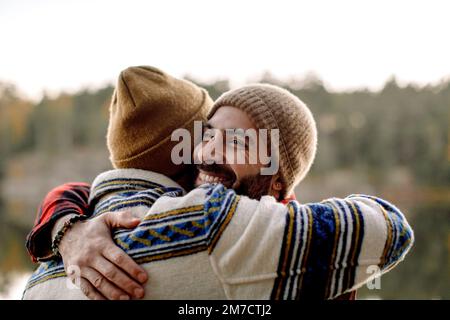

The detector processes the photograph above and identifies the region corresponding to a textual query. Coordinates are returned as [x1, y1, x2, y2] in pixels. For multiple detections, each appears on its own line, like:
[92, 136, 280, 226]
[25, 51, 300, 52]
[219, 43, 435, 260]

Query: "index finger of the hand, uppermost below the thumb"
[102, 243, 148, 284]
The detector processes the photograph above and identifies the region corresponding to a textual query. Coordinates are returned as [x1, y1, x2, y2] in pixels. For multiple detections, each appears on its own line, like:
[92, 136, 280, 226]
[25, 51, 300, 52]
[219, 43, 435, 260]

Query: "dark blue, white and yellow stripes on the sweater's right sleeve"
[271, 195, 414, 300]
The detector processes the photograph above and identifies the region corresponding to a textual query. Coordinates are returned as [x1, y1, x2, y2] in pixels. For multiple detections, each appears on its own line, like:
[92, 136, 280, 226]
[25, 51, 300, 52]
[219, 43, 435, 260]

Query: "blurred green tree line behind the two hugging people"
[0, 74, 450, 186]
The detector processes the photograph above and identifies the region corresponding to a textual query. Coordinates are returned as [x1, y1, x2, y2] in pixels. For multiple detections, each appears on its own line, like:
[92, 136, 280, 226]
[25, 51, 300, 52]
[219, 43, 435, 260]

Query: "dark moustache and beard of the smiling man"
[196, 163, 272, 200]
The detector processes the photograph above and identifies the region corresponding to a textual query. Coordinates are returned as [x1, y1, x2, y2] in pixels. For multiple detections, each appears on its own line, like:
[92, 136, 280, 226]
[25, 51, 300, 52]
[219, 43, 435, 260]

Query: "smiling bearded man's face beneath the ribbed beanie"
[193, 106, 277, 199]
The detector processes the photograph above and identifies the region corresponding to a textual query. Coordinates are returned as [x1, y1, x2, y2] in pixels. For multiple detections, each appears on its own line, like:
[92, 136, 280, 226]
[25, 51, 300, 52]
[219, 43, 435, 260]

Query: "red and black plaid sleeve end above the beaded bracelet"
[26, 183, 91, 262]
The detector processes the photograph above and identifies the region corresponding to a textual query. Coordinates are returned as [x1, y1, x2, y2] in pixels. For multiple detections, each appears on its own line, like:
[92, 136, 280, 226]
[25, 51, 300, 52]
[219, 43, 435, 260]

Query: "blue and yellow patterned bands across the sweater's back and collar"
[26, 179, 239, 289]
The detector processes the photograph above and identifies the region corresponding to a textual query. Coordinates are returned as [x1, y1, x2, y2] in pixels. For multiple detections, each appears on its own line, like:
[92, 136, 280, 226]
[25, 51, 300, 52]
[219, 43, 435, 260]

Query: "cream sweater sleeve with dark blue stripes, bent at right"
[211, 191, 414, 299]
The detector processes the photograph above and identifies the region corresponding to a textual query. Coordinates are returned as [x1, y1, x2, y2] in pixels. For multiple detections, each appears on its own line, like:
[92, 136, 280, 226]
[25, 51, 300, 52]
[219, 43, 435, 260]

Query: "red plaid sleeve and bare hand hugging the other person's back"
[26, 183, 147, 299]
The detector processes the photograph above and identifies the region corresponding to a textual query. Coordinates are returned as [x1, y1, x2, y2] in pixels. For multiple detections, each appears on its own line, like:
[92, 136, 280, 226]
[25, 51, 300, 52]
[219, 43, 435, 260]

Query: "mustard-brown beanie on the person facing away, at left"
[107, 66, 213, 177]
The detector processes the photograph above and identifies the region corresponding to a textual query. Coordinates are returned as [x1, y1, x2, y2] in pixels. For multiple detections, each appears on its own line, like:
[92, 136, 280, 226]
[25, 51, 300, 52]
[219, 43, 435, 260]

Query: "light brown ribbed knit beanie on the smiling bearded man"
[208, 84, 317, 197]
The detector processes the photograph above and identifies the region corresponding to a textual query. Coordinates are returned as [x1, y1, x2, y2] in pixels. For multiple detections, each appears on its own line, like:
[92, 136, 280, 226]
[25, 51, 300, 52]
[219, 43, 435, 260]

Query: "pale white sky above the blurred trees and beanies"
[0, 0, 450, 98]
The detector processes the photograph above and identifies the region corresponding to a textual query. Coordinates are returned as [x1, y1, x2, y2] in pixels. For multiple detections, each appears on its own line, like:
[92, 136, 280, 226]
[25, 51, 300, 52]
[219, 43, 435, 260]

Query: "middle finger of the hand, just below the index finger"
[92, 257, 144, 299]
